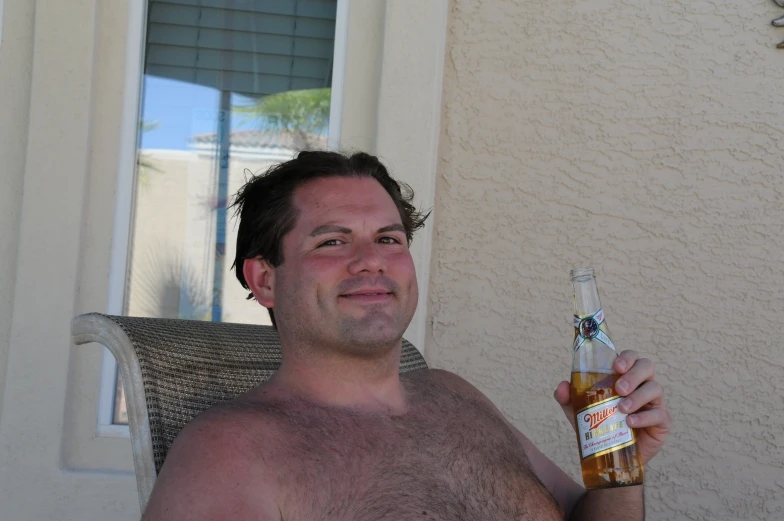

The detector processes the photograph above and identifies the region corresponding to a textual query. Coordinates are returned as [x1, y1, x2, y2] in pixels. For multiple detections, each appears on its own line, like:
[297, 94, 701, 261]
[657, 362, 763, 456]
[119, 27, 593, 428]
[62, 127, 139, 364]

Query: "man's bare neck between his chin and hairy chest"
[269, 345, 406, 415]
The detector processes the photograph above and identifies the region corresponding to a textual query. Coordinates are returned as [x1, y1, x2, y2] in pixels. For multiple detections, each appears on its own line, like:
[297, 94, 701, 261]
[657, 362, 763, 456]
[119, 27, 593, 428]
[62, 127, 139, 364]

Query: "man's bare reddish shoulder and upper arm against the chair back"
[142, 411, 281, 521]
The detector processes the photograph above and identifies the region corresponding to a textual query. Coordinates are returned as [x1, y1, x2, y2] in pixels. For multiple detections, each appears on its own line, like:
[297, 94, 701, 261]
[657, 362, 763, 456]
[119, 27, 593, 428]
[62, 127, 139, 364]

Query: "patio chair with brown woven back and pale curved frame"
[71, 313, 427, 511]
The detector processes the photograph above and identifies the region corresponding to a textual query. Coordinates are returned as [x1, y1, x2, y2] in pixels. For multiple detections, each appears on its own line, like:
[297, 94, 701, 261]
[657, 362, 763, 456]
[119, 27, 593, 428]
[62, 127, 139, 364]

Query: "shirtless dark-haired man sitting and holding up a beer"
[143, 152, 670, 521]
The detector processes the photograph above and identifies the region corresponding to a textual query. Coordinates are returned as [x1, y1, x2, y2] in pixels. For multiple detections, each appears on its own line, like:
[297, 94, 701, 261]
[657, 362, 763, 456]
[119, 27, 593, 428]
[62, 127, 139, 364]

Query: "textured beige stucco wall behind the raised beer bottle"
[426, 0, 784, 521]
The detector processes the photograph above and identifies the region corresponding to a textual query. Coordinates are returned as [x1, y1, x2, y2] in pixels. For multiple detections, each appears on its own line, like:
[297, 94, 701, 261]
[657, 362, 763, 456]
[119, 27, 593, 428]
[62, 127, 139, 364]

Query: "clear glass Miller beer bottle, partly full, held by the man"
[571, 268, 643, 490]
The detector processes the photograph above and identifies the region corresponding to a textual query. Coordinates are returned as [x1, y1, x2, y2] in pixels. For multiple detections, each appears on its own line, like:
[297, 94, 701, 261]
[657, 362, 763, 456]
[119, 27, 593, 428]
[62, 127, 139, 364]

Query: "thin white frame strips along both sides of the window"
[97, 0, 350, 432]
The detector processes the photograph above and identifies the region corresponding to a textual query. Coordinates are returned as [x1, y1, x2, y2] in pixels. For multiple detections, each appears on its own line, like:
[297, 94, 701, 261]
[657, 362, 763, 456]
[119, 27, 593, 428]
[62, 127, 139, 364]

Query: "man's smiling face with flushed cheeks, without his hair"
[273, 177, 418, 355]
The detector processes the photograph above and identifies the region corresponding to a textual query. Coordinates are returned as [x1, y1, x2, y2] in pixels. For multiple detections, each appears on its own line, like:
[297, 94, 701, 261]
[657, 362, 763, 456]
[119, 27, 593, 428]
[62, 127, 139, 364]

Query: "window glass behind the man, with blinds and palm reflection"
[114, 0, 337, 423]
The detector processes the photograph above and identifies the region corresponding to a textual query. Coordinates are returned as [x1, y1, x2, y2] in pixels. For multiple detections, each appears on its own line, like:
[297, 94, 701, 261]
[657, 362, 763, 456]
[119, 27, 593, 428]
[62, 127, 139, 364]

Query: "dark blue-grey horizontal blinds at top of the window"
[145, 0, 337, 97]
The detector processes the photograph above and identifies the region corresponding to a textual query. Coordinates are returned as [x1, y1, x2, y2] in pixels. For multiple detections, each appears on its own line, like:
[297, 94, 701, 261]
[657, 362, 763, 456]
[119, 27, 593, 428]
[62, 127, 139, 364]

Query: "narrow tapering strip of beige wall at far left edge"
[0, 0, 35, 422]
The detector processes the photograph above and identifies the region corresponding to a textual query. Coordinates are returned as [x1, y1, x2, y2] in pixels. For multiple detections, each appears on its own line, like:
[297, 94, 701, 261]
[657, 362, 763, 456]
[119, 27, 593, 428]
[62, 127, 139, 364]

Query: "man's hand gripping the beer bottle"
[553, 351, 672, 464]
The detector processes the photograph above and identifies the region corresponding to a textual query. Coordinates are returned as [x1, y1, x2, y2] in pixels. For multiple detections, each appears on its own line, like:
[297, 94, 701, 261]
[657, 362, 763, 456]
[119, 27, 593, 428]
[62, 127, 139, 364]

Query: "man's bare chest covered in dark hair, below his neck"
[270, 384, 562, 521]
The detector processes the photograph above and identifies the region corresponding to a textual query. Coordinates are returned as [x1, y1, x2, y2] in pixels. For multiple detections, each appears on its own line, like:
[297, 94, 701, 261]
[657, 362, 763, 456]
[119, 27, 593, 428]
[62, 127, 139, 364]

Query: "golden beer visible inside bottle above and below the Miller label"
[571, 373, 644, 489]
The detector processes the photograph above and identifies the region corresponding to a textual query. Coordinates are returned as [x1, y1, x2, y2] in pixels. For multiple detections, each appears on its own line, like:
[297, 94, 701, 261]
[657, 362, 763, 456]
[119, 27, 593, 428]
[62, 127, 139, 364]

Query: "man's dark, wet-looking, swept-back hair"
[232, 151, 430, 326]
